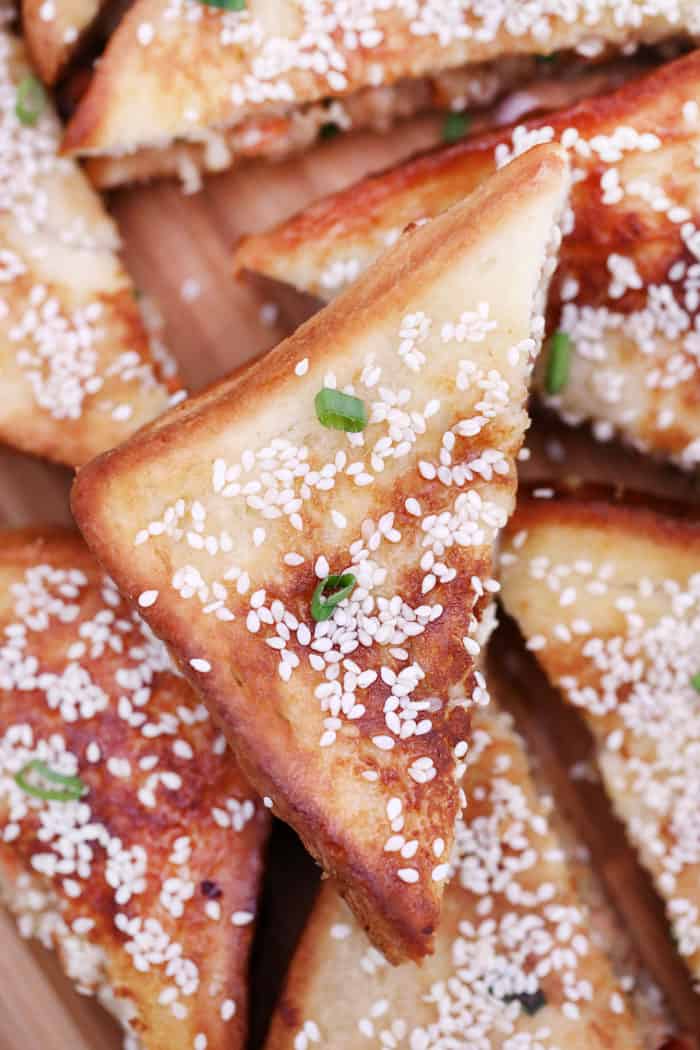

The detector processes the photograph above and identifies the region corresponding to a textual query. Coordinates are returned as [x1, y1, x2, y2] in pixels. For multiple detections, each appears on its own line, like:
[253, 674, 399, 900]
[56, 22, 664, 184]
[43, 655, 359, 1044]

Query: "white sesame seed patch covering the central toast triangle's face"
[128, 302, 542, 902]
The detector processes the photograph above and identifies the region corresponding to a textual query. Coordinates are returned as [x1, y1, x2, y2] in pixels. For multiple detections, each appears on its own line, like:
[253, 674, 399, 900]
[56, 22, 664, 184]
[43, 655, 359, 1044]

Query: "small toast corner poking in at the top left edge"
[21, 0, 108, 84]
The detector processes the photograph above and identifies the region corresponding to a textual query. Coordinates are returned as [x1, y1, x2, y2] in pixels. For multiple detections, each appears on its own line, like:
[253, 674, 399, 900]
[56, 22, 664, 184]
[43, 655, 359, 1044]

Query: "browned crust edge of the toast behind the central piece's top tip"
[234, 51, 700, 283]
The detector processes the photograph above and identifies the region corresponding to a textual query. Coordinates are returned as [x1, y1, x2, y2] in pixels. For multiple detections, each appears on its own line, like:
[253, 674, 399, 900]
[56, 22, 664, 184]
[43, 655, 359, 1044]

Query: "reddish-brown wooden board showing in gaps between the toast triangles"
[0, 120, 700, 1050]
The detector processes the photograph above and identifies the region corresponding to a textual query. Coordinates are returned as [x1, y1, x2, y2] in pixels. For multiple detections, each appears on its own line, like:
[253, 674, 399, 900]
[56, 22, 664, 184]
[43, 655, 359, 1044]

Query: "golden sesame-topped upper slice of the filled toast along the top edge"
[65, 0, 698, 160]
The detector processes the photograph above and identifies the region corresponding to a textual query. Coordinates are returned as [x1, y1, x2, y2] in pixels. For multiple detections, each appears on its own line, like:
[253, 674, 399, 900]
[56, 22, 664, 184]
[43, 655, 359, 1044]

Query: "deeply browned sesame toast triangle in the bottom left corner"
[0, 529, 269, 1050]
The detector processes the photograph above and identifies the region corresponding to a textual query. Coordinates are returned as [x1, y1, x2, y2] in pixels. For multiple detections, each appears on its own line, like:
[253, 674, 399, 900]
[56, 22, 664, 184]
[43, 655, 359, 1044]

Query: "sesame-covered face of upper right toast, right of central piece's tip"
[505, 92, 700, 469]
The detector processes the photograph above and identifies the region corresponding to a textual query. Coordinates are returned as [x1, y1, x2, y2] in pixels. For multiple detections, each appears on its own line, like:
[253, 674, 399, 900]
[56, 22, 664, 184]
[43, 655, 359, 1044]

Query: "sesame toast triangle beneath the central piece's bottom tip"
[266, 699, 661, 1050]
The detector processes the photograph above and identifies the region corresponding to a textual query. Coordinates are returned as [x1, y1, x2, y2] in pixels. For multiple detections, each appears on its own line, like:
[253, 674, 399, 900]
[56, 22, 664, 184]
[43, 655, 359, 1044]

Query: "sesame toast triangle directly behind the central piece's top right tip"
[236, 50, 700, 468]
